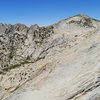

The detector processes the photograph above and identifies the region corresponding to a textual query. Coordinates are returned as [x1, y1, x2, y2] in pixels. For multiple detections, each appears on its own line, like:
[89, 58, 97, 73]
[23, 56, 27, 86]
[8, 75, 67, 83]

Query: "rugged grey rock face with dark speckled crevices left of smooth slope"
[0, 24, 53, 70]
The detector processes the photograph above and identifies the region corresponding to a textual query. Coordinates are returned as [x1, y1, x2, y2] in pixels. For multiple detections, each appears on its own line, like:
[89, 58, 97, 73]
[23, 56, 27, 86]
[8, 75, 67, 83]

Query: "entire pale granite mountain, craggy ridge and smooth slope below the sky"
[0, 14, 100, 100]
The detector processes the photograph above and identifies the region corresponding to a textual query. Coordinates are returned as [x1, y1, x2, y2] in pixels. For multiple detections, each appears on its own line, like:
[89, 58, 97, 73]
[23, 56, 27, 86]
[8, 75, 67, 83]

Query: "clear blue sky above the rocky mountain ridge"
[0, 0, 100, 26]
